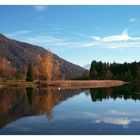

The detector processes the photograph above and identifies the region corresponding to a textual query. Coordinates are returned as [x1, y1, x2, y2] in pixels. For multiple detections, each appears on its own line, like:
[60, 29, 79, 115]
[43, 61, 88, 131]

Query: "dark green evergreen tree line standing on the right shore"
[89, 60, 140, 81]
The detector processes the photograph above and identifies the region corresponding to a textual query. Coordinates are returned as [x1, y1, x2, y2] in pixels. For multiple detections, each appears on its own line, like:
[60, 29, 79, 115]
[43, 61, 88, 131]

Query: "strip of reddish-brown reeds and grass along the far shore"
[0, 80, 127, 89]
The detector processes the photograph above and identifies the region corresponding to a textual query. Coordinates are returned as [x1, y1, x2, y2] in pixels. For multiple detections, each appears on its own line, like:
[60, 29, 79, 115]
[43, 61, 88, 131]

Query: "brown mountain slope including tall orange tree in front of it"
[0, 34, 88, 80]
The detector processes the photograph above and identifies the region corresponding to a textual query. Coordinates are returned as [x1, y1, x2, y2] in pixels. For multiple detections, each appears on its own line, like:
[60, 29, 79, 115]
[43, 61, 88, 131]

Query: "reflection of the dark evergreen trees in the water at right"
[90, 85, 140, 102]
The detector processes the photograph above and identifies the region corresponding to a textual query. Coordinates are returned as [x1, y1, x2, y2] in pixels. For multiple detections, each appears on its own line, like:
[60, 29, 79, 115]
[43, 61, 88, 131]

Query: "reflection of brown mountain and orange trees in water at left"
[0, 88, 82, 128]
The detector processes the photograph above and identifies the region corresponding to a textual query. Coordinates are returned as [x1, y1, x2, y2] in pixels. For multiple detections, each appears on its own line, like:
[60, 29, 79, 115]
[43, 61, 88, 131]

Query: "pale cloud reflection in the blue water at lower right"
[83, 110, 140, 128]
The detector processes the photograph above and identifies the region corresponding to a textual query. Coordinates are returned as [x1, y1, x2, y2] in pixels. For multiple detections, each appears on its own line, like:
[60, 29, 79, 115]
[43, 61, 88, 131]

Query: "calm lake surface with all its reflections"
[0, 85, 140, 135]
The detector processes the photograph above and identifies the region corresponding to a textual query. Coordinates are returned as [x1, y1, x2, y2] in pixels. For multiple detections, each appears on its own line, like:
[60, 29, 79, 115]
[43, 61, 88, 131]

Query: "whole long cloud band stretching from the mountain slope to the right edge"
[7, 28, 140, 49]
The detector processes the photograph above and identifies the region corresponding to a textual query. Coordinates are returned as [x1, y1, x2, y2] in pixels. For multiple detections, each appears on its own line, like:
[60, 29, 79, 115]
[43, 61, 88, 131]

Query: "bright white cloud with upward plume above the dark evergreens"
[84, 29, 140, 48]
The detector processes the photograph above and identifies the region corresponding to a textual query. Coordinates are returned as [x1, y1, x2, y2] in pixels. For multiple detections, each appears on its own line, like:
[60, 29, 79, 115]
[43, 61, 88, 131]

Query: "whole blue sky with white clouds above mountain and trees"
[0, 5, 140, 66]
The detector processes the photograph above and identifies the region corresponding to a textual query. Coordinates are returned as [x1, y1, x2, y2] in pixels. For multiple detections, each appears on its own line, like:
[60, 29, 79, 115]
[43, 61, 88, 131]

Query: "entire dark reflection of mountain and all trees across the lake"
[0, 85, 140, 128]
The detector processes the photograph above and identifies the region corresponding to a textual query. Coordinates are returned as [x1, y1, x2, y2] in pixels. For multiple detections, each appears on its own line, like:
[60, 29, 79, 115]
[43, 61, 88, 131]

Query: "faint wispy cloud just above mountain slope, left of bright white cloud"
[5, 30, 87, 50]
